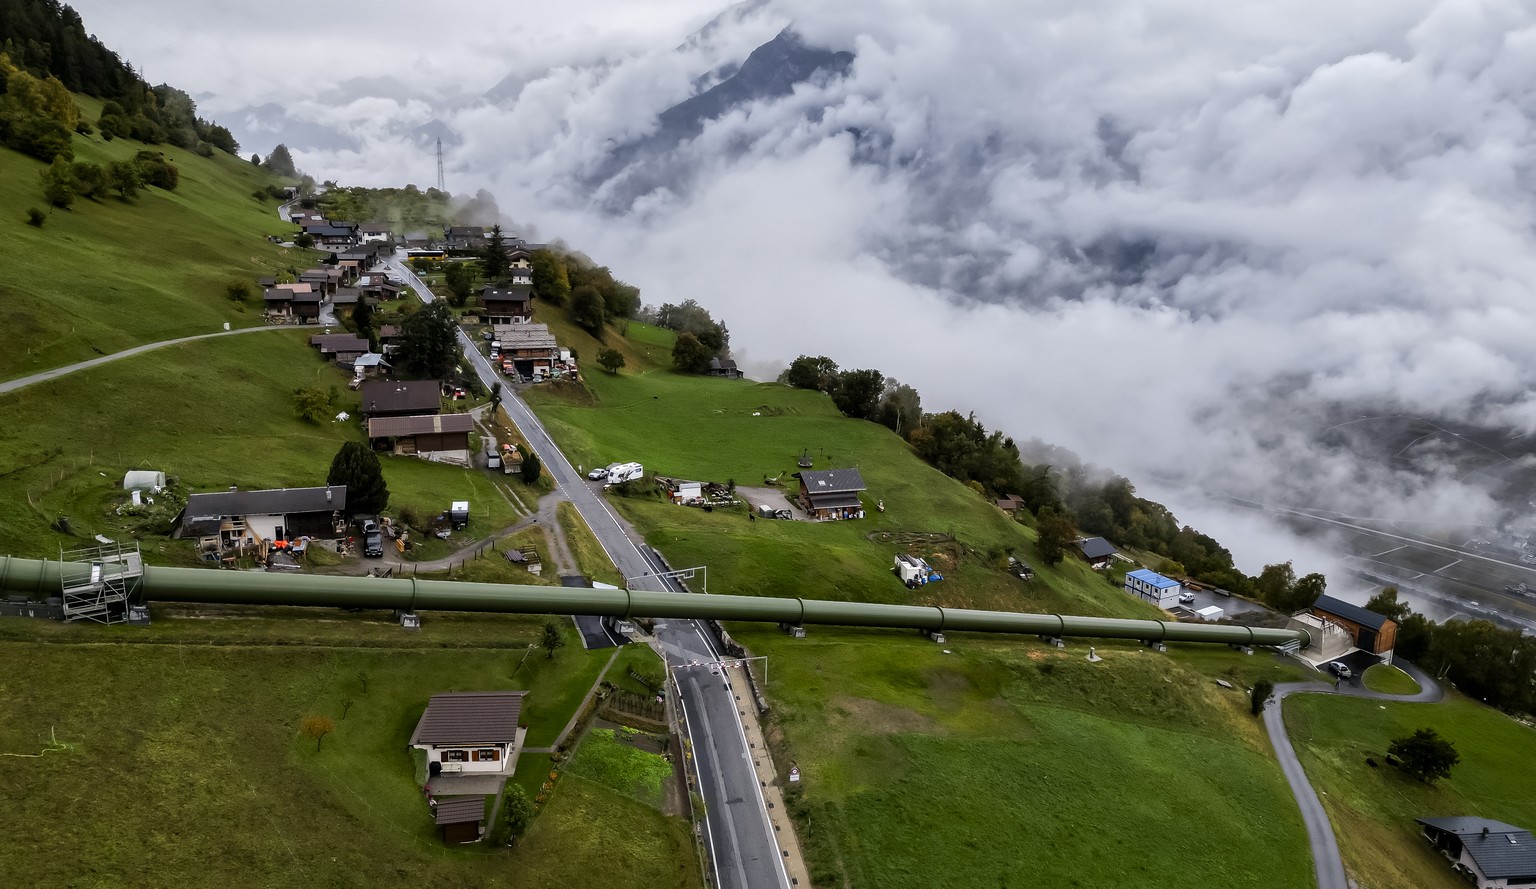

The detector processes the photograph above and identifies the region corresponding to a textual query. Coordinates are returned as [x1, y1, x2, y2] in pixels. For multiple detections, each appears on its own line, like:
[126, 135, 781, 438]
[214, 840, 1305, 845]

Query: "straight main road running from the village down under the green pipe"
[389, 256, 790, 889]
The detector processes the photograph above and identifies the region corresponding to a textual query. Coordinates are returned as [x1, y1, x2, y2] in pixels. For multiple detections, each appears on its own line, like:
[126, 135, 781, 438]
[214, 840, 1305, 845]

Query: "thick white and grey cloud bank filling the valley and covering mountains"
[74, 0, 1536, 568]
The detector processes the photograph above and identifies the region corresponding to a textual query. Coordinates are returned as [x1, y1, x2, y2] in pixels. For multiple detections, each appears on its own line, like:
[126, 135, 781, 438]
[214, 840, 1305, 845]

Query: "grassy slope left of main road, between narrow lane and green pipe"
[0, 330, 531, 562]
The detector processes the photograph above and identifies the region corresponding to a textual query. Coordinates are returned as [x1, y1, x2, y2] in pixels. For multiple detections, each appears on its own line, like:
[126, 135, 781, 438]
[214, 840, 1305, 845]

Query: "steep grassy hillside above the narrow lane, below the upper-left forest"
[0, 97, 309, 379]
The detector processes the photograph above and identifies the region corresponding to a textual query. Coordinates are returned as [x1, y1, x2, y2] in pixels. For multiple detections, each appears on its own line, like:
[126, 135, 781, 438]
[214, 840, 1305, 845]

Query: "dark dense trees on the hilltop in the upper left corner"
[0, 0, 240, 161]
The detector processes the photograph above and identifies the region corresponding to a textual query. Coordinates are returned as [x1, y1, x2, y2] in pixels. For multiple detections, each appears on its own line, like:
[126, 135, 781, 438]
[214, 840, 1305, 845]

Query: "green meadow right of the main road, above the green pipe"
[527, 307, 1157, 617]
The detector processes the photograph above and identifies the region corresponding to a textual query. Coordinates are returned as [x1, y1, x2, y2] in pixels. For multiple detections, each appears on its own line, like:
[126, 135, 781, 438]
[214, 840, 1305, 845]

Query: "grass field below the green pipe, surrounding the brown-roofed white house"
[0, 610, 697, 889]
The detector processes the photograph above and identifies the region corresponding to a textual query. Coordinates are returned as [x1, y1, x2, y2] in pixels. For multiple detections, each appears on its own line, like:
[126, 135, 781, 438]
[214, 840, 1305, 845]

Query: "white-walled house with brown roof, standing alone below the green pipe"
[410, 691, 528, 782]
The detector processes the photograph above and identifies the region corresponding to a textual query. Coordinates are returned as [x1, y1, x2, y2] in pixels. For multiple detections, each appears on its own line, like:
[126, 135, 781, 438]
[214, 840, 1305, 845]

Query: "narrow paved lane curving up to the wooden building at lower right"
[1264, 662, 1444, 889]
